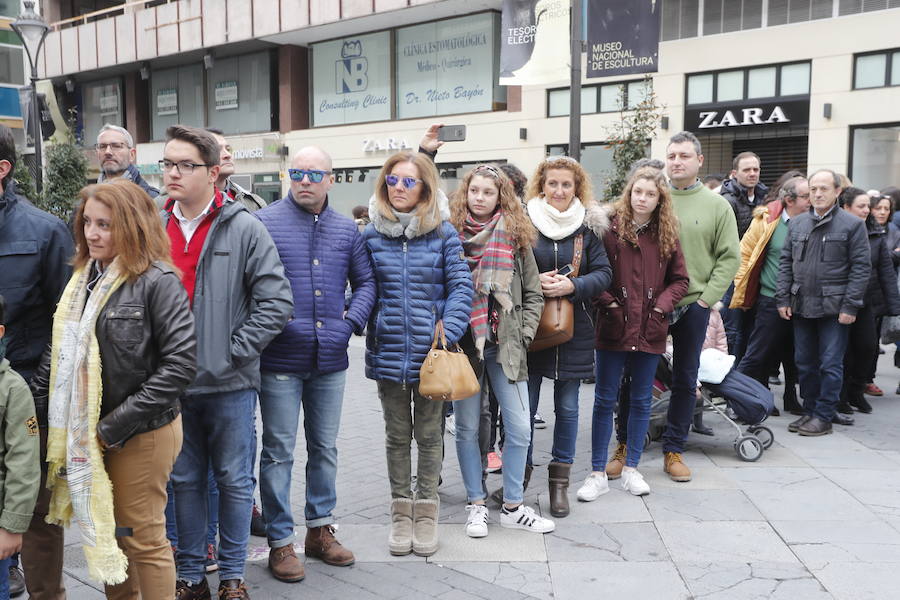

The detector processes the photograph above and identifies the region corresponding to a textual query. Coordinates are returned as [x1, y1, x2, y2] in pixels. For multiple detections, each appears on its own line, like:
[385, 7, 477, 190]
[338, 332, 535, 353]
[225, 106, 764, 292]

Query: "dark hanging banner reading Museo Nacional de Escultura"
[587, 0, 662, 77]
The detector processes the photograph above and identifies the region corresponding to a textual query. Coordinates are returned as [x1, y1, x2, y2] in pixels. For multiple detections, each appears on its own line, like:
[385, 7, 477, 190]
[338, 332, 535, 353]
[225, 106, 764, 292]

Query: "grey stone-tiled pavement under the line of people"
[66, 338, 900, 600]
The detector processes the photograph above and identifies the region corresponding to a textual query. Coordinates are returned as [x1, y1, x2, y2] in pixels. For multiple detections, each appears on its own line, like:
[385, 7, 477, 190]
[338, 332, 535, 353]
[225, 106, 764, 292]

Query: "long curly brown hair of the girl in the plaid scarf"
[450, 165, 537, 252]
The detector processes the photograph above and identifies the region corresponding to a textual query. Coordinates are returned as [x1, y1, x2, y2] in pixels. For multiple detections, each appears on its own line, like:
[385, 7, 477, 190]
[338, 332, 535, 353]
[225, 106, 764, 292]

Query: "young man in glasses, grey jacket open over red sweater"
[160, 125, 293, 600]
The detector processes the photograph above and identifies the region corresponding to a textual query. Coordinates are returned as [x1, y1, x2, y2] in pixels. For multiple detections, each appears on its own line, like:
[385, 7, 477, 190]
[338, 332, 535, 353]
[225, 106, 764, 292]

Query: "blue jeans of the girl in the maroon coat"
[596, 350, 659, 471]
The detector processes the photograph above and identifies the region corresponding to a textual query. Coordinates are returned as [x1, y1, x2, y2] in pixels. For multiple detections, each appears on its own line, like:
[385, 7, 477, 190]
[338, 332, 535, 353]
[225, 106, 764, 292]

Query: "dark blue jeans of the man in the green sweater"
[660, 302, 709, 452]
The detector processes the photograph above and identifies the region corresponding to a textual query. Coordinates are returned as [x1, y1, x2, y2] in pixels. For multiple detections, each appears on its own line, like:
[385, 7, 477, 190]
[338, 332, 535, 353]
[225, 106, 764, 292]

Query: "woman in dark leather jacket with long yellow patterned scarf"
[32, 180, 197, 600]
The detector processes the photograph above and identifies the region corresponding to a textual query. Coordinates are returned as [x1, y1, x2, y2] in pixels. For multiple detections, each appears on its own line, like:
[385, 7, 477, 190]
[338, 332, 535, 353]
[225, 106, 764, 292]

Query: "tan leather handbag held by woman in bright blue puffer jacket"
[419, 321, 481, 402]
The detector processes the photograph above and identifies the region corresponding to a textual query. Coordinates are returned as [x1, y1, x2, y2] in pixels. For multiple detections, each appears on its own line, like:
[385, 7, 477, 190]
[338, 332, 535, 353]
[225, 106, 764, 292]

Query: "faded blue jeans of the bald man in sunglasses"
[259, 371, 347, 548]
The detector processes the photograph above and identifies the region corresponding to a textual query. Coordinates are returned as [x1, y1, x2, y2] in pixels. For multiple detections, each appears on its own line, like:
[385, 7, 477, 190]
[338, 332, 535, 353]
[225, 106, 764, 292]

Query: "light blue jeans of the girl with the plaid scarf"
[453, 345, 531, 504]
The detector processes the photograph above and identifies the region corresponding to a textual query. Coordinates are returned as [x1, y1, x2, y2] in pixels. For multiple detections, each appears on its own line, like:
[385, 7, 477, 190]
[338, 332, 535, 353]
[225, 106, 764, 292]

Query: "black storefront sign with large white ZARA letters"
[684, 100, 809, 131]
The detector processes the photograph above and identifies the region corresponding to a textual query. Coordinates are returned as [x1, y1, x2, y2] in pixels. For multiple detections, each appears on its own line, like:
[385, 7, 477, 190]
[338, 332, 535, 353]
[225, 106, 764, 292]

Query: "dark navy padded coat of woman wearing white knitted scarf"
[528, 205, 612, 379]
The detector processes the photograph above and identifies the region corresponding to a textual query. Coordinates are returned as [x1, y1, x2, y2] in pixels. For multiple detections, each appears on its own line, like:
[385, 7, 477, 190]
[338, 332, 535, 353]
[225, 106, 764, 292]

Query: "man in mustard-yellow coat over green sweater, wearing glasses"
[731, 177, 810, 415]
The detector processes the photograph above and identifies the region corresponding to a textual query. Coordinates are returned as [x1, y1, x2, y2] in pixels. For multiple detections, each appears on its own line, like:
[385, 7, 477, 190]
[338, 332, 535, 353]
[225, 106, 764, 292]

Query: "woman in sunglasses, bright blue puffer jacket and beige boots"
[363, 152, 472, 556]
